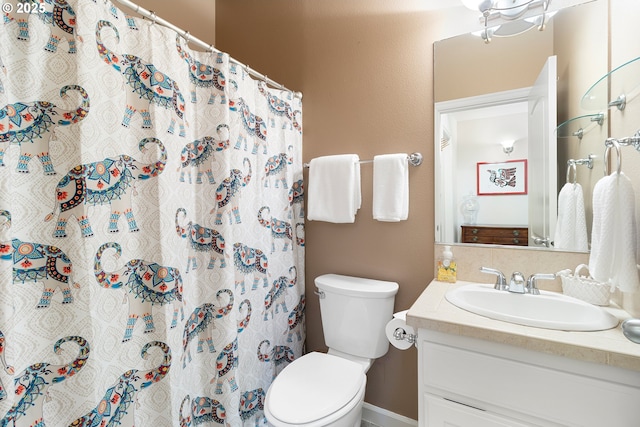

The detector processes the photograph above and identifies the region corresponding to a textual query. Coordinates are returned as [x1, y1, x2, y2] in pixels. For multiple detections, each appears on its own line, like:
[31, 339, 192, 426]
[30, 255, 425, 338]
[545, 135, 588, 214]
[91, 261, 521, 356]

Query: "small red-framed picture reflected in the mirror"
[476, 159, 527, 196]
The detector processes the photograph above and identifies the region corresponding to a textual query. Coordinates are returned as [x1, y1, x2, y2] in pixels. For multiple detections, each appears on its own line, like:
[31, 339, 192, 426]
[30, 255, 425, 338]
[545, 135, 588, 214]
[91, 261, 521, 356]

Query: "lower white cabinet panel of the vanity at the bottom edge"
[420, 393, 533, 427]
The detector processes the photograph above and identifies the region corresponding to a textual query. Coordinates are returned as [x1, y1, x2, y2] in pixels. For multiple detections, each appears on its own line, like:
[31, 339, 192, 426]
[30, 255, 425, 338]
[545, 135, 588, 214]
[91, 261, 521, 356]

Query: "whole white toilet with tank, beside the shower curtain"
[264, 274, 398, 427]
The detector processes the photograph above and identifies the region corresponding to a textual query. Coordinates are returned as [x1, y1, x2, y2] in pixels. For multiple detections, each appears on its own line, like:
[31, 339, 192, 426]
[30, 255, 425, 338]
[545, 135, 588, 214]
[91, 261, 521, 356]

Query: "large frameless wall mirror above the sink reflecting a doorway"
[434, 0, 609, 248]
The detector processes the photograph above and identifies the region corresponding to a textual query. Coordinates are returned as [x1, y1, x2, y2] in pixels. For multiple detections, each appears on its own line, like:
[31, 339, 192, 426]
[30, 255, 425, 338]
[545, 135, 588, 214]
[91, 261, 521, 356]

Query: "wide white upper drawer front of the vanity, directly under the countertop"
[418, 338, 640, 427]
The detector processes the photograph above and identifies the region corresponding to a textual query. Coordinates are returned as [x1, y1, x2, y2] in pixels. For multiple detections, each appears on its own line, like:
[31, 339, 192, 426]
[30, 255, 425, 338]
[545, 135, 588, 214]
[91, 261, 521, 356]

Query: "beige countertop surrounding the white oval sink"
[407, 280, 640, 371]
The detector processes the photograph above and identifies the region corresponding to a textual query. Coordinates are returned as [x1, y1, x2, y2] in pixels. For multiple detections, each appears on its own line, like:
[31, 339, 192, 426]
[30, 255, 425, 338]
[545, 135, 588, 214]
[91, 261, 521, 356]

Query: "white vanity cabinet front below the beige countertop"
[417, 328, 640, 427]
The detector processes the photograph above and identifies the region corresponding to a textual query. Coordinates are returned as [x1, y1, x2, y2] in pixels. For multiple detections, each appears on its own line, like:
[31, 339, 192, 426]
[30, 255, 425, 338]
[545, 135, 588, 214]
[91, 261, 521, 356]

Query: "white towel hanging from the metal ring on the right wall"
[589, 173, 640, 292]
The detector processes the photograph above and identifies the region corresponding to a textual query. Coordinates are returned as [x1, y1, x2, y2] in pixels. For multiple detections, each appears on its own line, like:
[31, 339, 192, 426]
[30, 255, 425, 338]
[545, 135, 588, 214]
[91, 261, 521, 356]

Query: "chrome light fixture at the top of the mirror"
[461, 0, 555, 43]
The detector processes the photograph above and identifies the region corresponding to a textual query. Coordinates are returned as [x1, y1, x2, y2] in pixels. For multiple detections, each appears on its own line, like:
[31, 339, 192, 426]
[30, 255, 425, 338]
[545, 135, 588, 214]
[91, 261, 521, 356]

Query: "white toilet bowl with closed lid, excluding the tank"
[264, 352, 367, 427]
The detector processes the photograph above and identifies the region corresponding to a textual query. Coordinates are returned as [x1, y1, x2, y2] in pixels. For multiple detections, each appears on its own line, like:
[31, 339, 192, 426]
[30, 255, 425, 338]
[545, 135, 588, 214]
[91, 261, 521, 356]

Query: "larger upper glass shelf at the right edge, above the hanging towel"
[580, 57, 640, 111]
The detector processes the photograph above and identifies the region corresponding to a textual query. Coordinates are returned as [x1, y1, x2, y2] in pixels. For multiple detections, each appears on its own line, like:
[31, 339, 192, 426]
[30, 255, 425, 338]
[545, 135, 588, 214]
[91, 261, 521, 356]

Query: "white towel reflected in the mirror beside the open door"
[553, 183, 589, 251]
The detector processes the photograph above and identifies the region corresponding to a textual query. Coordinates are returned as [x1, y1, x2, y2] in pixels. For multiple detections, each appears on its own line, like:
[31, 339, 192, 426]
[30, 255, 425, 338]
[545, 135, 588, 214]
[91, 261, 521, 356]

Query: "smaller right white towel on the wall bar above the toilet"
[373, 153, 409, 222]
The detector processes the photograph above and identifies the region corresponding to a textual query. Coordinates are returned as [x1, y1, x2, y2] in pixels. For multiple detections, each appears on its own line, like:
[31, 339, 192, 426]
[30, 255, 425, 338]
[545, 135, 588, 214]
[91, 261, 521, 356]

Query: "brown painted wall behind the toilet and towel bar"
[216, 0, 437, 419]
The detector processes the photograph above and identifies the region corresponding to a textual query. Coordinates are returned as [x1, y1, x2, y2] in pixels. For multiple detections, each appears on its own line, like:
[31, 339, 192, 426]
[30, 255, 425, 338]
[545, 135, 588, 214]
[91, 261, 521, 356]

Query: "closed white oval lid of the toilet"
[267, 352, 366, 424]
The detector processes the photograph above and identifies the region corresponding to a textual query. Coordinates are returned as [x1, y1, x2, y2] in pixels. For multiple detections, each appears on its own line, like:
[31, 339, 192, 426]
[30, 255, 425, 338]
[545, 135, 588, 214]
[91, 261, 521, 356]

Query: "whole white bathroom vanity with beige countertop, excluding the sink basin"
[407, 281, 640, 427]
